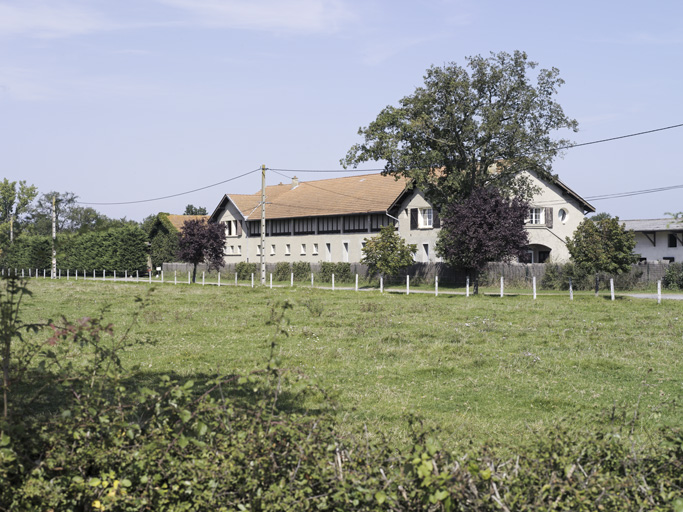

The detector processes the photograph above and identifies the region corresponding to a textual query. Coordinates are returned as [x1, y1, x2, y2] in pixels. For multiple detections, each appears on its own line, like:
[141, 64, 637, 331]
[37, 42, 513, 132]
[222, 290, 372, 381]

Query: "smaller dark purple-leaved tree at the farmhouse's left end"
[178, 220, 225, 283]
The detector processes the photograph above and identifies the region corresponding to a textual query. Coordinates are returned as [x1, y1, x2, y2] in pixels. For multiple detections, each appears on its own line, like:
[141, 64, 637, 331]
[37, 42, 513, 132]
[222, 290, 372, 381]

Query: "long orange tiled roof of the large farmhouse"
[229, 174, 407, 219]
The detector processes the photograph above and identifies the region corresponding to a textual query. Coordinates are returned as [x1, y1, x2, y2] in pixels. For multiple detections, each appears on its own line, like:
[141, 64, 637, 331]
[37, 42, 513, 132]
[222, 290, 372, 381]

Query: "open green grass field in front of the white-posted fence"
[18, 279, 683, 448]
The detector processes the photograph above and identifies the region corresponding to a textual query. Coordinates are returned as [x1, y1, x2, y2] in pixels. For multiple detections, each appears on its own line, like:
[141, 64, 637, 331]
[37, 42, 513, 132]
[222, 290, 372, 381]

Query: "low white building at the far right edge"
[622, 219, 683, 263]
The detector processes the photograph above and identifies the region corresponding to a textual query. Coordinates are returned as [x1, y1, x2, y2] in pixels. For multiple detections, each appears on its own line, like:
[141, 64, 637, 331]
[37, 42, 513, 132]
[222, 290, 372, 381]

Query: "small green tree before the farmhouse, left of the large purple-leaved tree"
[361, 226, 417, 276]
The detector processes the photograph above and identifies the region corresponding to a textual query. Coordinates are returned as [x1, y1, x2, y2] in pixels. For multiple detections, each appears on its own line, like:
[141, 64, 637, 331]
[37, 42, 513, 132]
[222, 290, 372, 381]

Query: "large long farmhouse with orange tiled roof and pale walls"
[209, 174, 595, 263]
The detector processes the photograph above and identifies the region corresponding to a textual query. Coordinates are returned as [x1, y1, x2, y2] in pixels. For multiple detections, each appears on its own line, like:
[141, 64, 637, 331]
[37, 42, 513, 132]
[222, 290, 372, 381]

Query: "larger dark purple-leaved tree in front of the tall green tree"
[436, 188, 529, 293]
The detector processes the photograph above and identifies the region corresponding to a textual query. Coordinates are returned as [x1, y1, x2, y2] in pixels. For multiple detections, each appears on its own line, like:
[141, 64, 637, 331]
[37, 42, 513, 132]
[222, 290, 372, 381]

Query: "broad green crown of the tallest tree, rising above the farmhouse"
[341, 51, 578, 208]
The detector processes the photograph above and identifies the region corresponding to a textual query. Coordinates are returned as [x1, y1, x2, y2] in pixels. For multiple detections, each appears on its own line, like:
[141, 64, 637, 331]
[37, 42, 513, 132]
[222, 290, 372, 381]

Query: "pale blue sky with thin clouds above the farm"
[0, 0, 683, 220]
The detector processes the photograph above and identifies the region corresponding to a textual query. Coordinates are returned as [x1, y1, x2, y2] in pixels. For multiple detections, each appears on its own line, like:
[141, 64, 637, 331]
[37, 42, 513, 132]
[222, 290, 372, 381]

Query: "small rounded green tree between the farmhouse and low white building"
[567, 214, 638, 296]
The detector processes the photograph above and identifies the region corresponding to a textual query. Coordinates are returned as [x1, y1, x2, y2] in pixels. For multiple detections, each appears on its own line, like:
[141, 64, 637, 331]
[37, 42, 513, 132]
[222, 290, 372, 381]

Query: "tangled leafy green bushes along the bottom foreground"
[0, 280, 683, 512]
